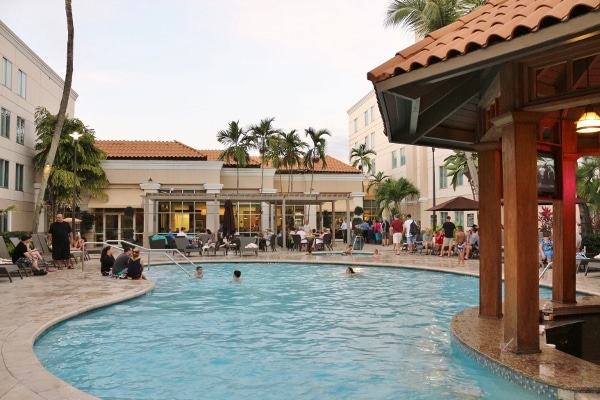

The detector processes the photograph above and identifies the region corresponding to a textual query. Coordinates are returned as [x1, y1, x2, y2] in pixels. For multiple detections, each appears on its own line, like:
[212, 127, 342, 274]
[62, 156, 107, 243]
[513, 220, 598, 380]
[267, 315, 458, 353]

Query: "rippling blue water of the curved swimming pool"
[35, 264, 550, 399]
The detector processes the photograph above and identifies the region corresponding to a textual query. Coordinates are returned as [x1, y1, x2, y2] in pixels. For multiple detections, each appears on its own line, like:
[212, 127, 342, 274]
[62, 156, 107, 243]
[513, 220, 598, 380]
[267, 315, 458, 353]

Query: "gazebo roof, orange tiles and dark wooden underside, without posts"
[368, 0, 600, 150]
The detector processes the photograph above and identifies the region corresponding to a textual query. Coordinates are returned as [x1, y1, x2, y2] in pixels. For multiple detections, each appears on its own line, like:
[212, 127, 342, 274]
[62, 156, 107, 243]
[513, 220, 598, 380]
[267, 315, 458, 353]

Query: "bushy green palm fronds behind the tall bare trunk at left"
[33, 107, 109, 212]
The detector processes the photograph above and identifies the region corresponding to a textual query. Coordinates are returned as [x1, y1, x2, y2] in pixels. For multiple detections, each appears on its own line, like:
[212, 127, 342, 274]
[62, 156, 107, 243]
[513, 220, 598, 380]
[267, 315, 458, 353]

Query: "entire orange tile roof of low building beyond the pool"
[95, 140, 360, 173]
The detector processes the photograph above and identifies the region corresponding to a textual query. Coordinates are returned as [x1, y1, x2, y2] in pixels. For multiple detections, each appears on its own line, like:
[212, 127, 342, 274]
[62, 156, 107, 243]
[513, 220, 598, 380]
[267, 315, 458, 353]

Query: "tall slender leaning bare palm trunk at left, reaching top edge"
[32, 0, 75, 232]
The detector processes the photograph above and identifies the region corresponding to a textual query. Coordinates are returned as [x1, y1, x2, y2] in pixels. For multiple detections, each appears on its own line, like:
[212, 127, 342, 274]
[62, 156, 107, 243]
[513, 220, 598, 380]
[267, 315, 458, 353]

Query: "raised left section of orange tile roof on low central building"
[95, 140, 207, 160]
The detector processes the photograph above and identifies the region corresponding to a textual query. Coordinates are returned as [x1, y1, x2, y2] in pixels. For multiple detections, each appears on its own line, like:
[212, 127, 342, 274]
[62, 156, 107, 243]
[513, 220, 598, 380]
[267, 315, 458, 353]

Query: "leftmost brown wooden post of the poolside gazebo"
[475, 141, 502, 318]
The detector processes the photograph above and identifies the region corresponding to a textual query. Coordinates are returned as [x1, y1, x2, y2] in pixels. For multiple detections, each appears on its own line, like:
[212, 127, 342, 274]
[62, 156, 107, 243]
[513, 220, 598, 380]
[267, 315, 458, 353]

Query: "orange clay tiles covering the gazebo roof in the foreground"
[367, 0, 600, 83]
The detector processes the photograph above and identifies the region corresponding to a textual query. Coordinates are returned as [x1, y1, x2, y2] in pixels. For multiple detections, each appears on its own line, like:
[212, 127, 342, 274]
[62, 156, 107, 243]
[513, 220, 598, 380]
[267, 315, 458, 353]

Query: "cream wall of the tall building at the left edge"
[0, 21, 77, 231]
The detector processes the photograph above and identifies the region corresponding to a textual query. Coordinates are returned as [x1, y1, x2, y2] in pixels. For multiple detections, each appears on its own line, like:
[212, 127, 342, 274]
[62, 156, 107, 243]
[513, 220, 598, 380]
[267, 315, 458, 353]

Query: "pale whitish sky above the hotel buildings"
[0, 0, 413, 162]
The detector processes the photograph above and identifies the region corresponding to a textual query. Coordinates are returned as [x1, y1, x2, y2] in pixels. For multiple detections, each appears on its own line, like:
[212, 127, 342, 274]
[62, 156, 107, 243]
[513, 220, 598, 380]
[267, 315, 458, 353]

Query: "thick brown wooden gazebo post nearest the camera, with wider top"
[493, 111, 542, 354]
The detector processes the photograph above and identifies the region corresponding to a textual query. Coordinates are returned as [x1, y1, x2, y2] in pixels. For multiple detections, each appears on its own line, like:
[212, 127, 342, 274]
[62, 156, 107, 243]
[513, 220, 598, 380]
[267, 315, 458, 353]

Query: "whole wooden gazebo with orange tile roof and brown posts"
[368, 0, 600, 354]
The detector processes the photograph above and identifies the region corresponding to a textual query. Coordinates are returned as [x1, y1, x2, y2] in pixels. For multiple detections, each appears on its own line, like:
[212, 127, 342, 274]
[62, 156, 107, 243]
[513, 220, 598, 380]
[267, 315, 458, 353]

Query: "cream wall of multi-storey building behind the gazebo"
[348, 91, 477, 227]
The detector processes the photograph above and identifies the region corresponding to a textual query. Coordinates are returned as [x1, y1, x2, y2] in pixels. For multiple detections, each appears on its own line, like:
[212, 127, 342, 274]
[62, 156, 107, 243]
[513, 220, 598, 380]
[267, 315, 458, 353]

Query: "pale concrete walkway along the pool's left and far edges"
[0, 242, 600, 400]
